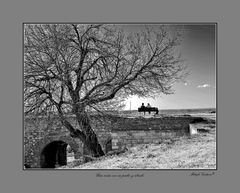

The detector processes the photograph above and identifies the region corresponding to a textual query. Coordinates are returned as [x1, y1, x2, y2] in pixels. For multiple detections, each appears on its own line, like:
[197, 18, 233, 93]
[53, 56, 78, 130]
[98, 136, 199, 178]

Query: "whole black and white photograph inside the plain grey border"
[22, 22, 218, 171]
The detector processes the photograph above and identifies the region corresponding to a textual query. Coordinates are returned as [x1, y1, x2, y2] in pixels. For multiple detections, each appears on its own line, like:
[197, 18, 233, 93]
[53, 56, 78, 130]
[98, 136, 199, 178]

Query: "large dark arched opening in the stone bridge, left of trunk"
[40, 141, 68, 168]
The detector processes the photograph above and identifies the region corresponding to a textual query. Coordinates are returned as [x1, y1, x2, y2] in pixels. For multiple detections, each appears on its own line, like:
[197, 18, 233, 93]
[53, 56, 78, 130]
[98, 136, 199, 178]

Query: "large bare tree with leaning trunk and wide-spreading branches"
[24, 24, 188, 157]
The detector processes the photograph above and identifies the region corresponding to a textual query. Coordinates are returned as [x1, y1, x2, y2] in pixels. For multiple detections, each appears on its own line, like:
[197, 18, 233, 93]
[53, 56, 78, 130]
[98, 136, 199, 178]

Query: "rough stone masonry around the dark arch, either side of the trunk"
[24, 116, 111, 168]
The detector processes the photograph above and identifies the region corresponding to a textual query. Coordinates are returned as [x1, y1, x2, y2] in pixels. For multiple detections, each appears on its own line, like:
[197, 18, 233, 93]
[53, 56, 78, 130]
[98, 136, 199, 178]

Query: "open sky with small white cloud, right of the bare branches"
[125, 24, 216, 110]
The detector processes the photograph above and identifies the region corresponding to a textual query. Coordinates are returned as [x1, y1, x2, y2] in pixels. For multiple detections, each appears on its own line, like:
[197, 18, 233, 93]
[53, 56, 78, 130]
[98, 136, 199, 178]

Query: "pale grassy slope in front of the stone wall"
[58, 120, 216, 169]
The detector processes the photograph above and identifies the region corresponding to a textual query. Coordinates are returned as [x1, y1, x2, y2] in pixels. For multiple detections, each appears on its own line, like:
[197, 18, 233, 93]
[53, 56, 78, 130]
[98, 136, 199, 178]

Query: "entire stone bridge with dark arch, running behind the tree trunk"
[24, 116, 202, 168]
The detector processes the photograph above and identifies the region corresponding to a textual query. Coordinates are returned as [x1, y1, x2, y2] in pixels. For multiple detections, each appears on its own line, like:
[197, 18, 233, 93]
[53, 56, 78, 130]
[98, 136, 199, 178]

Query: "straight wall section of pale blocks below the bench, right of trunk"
[111, 116, 201, 150]
